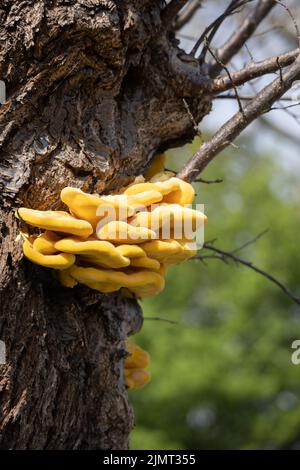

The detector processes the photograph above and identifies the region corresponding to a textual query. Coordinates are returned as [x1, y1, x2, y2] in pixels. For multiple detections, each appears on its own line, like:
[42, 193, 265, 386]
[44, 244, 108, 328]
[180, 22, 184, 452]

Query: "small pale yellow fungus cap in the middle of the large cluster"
[97, 221, 156, 244]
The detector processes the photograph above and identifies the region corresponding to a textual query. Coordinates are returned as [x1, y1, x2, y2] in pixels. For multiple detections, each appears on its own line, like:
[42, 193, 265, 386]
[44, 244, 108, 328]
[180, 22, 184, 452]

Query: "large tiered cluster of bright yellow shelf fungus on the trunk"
[17, 162, 206, 298]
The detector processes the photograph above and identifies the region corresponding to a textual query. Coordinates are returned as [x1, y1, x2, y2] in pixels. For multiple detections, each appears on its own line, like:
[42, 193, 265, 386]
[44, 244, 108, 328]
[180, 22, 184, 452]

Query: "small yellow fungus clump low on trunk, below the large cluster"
[124, 341, 151, 390]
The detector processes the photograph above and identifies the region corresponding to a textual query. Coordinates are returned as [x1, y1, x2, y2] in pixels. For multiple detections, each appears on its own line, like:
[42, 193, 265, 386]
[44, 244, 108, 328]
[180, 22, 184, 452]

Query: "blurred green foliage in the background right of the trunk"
[130, 136, 300, 449]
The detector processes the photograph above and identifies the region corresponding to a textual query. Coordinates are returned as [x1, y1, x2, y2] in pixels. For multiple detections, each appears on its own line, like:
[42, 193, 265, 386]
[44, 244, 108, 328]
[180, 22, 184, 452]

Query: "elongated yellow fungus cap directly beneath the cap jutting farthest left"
[55, 237, 130, 268]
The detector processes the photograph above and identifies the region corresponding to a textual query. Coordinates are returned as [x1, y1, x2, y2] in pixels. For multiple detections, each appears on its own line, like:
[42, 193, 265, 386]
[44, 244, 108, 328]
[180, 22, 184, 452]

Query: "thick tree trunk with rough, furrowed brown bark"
[0, 0, 211, 449]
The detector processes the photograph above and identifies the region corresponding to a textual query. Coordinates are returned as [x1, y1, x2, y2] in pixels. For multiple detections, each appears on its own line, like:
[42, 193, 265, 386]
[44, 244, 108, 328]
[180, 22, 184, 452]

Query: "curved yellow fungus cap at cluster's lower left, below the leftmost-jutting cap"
[23, 240, 75, 269]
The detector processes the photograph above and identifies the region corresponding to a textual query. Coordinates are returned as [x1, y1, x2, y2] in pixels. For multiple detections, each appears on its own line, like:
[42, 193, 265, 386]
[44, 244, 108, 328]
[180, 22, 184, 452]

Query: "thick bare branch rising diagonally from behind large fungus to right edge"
[178, 55, 300, 181]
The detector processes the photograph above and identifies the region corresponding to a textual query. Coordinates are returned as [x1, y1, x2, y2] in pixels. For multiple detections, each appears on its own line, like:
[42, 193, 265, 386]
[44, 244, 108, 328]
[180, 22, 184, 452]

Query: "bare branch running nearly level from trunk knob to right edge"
[211, 48, 300, 93]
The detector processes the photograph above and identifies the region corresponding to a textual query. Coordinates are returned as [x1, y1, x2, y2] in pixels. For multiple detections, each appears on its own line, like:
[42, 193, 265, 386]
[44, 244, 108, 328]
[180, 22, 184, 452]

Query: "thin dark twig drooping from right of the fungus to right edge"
[191, 243, 300, 305]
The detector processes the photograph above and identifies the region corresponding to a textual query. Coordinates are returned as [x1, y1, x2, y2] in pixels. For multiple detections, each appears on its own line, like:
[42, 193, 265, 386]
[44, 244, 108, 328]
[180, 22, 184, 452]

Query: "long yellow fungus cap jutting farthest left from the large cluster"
[18, 207, 93, 237]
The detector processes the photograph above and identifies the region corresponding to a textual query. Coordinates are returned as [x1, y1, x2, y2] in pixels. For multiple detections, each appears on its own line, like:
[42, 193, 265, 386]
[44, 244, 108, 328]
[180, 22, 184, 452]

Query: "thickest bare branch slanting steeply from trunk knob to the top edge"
[210, 0, 276, 77]
